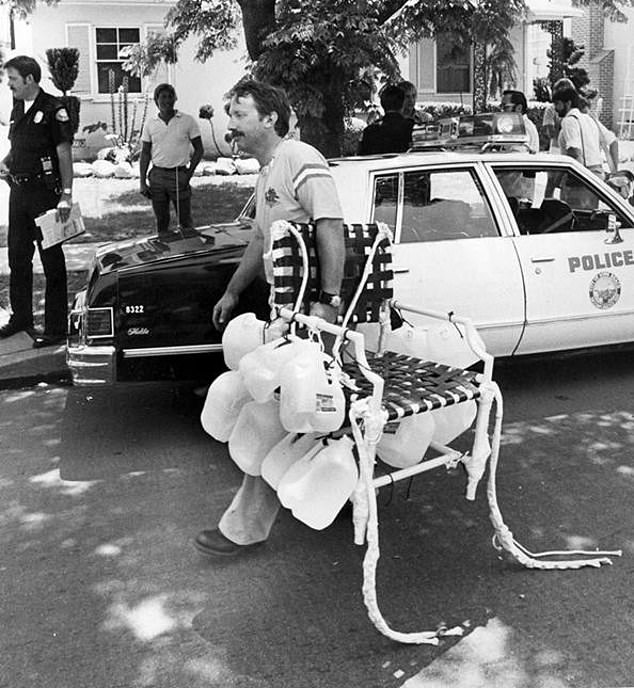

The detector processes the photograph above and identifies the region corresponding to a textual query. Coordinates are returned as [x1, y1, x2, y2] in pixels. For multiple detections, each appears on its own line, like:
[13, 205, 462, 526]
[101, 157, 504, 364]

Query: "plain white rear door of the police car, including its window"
[372, 164, 524, 355]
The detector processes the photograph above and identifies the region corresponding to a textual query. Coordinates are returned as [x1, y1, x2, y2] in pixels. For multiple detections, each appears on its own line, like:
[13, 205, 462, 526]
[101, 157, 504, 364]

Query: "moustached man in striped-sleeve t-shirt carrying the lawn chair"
[194, 81, 345, 556]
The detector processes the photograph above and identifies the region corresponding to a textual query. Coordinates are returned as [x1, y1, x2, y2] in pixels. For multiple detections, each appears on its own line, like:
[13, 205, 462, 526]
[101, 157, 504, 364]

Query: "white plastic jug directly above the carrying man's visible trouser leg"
[229, 400, 286, 475]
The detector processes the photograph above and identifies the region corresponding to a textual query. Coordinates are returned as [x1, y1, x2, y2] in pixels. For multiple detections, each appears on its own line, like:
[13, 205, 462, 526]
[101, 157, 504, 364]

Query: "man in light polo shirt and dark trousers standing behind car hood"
[140, 84, 203, 238]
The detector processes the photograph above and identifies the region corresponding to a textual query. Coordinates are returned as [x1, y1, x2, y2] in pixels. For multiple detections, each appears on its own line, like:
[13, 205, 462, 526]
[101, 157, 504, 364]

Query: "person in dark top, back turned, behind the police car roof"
[359, 85, 414, 155]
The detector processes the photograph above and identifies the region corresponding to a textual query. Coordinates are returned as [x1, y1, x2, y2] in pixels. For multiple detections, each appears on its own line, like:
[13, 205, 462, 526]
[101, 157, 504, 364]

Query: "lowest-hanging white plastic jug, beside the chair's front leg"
[277, 436, 359, 530]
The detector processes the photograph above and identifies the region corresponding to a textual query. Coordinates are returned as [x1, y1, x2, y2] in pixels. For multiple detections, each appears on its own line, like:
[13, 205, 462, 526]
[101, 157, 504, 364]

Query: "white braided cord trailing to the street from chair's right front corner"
[487, 382, 623, 571]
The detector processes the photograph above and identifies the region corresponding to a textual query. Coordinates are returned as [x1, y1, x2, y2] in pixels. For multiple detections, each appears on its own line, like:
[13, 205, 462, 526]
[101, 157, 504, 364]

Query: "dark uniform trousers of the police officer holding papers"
[8, 180, 68, 336]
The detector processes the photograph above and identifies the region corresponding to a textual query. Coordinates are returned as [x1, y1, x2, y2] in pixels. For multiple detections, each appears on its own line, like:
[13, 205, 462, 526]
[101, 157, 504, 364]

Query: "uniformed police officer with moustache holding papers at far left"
[0, 55, 73, 348]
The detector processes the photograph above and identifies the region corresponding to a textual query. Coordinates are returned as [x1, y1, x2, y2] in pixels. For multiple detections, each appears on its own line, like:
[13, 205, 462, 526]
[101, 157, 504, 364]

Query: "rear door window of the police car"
[400, 170, 498, 243]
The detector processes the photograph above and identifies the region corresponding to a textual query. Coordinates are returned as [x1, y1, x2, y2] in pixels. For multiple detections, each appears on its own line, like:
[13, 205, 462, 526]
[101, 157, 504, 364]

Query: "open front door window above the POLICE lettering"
[493, 167, 631, 234]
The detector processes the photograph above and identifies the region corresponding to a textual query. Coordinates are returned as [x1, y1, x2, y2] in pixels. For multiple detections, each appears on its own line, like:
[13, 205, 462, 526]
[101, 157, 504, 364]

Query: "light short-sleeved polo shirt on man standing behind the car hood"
[141, 110, 200, 168]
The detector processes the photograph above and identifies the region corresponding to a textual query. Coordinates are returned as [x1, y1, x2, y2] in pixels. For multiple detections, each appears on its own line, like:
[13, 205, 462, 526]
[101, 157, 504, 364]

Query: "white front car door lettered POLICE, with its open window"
[493, 162, 634, 354]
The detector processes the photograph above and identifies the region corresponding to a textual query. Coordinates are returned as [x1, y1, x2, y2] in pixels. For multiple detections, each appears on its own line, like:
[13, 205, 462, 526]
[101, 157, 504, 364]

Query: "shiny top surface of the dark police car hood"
[95, 221, 252, 274]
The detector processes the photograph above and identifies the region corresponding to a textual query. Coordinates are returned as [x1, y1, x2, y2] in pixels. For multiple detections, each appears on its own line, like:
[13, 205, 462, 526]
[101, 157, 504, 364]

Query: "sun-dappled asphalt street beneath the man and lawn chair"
[0, 353, 634, 688]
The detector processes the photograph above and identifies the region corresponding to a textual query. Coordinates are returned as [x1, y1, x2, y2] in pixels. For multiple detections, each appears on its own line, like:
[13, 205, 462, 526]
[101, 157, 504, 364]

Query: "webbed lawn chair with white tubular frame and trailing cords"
[271, 221, 621, 644]
